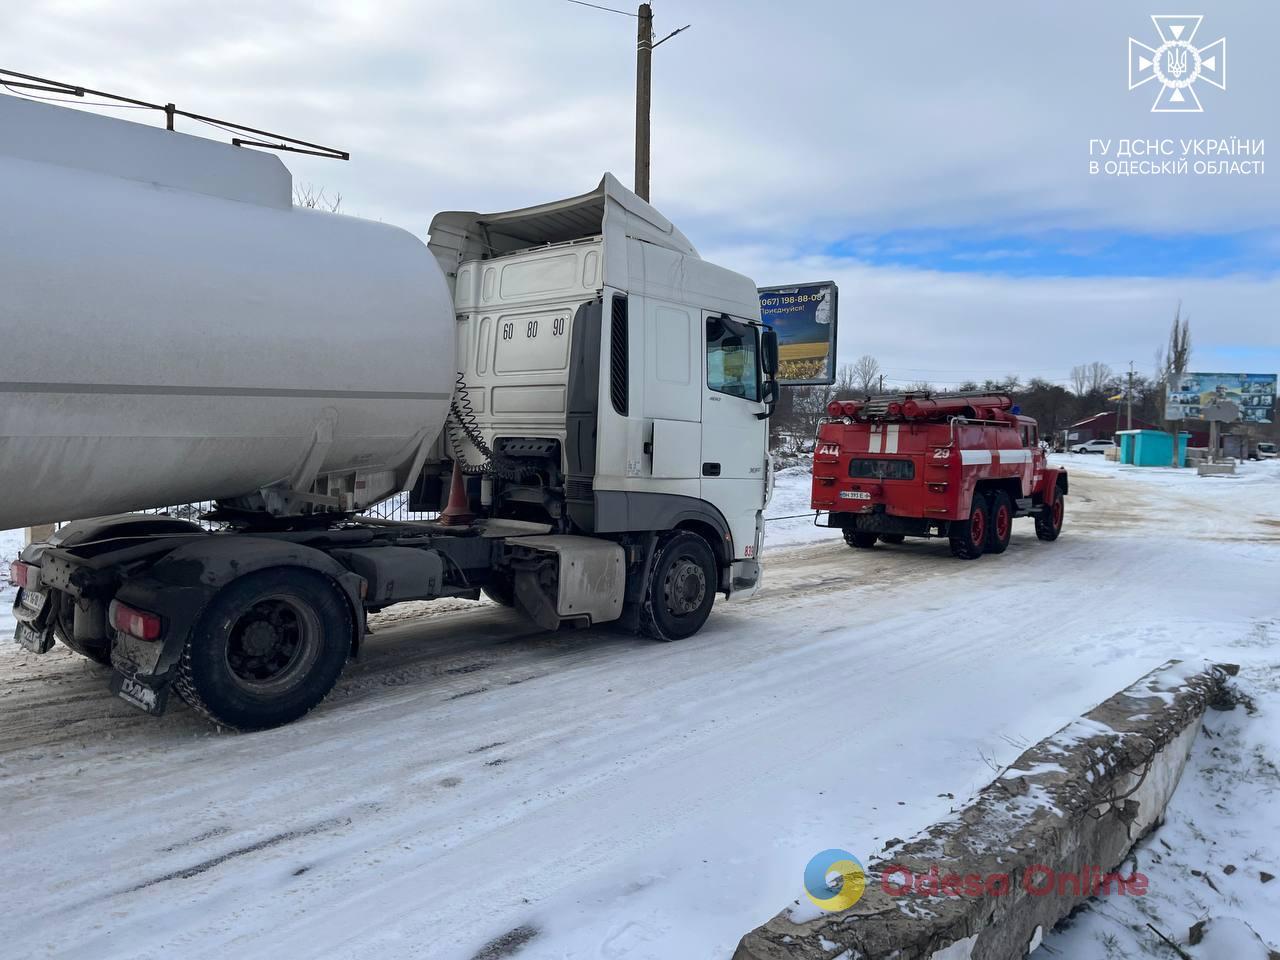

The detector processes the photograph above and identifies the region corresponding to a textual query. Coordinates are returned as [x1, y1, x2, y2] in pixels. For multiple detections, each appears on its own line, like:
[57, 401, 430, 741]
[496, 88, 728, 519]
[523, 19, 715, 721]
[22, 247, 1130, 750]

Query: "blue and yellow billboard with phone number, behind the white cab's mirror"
[759, 280, 838, 387]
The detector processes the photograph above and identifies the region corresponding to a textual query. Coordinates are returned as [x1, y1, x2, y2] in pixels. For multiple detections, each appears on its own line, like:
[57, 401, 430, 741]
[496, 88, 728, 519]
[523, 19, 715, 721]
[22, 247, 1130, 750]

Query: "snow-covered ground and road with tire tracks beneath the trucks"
[0, 456, 1280, 960]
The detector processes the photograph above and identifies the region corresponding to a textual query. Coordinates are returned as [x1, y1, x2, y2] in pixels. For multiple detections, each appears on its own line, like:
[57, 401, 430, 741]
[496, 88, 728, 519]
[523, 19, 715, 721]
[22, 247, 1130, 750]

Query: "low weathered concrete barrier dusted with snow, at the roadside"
[733, 660, 1234, 960]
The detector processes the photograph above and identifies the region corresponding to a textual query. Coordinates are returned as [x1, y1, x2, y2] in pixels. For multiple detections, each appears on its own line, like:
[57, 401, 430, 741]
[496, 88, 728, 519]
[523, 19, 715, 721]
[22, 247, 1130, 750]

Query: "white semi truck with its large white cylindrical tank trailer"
[0, 96, 777, 730]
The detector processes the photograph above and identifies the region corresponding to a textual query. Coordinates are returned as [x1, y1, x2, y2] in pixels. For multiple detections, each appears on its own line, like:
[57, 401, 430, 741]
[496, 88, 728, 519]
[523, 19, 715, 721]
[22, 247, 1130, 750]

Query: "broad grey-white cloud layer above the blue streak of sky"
[0, 0, 1280, 242]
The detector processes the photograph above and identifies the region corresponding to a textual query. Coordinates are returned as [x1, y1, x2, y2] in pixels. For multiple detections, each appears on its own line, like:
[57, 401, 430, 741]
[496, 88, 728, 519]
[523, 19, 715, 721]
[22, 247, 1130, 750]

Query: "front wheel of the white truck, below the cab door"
[640, 530, 719, 640]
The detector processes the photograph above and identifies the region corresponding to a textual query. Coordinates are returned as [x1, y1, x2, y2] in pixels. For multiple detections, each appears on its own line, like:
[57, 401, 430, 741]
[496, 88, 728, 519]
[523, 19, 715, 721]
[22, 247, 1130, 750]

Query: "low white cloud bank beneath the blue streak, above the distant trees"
[703, 247, 1280, 385]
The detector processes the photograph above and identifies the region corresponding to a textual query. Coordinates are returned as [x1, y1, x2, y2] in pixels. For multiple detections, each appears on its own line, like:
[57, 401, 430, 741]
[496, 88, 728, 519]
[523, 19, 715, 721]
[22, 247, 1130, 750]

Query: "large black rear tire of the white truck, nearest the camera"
[174, 567, 352, 730]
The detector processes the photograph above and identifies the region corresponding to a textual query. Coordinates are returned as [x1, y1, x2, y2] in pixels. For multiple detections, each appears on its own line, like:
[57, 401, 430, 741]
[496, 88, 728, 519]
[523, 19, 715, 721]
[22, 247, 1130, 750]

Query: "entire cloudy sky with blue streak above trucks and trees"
[0, 0, 1280, 385]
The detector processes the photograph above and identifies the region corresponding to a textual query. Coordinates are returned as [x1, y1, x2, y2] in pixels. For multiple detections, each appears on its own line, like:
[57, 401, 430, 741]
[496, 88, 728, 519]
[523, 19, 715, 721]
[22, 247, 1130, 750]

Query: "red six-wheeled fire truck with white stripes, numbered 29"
[813, 392, 1068, 559]
